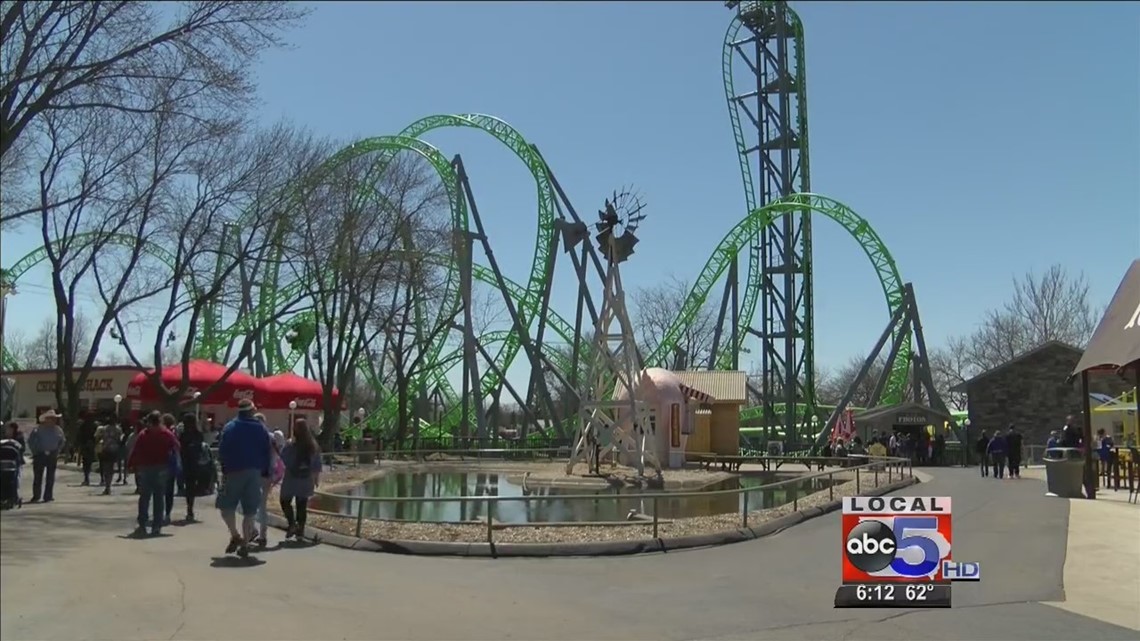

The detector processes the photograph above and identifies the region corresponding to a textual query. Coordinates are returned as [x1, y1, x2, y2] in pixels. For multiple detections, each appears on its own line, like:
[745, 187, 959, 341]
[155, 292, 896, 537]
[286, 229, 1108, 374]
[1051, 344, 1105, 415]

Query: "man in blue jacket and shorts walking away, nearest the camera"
[215, 399, 270, 557]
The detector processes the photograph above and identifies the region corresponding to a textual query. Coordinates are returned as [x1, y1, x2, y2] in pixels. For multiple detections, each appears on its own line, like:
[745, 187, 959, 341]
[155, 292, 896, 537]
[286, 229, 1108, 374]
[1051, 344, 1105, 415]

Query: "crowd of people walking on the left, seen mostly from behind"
[5, 400, 330, 557]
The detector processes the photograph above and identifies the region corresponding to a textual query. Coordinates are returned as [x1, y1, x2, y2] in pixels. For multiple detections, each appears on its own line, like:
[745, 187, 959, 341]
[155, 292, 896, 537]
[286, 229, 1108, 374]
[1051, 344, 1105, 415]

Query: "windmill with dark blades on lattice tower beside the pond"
[567, 192, 661, 476]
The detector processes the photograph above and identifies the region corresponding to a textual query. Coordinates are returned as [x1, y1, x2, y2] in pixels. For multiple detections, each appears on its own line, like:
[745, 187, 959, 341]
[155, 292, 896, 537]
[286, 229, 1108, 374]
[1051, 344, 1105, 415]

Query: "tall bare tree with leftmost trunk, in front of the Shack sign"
[0, 1, 301, 423]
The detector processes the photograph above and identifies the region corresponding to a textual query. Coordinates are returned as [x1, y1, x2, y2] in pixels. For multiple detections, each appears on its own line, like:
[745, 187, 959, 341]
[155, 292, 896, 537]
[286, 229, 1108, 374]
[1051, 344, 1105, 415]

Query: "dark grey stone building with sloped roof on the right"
[967, 346, 1132, 446]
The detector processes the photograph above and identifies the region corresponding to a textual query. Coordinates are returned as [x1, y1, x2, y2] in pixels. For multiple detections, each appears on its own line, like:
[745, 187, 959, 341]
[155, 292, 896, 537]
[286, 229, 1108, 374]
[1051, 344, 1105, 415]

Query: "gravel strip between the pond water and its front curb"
[296, 471, 897, 543]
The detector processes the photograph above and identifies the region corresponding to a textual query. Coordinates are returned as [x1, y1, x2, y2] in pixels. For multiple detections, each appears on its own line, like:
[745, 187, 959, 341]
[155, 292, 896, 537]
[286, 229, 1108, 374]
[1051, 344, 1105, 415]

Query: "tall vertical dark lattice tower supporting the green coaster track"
[725, 0, 815, 447]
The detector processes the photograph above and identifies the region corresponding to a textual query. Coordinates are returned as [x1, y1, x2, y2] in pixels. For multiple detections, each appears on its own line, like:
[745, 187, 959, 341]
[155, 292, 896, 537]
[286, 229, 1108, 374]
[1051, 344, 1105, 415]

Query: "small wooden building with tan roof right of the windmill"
[675, 370, 748, 456]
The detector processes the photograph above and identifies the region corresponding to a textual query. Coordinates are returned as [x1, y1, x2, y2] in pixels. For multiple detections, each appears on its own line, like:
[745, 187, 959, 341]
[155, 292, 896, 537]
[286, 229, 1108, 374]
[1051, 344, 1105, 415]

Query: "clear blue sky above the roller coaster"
[0, 1, 1140, 366]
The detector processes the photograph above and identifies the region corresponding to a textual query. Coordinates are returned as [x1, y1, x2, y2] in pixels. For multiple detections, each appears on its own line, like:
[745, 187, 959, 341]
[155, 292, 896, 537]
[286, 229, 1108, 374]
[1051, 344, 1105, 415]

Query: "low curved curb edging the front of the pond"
[273, 477, 919, 558]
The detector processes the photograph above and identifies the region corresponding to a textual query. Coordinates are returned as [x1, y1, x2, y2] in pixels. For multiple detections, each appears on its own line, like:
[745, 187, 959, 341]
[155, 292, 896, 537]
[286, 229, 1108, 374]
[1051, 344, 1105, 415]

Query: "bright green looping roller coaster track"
[3, 2, 910, 444]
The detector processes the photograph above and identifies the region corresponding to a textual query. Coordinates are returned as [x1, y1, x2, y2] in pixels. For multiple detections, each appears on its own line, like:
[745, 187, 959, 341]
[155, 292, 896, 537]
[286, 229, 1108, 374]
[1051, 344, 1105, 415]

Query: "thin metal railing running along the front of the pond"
[316, 457, 913, 544]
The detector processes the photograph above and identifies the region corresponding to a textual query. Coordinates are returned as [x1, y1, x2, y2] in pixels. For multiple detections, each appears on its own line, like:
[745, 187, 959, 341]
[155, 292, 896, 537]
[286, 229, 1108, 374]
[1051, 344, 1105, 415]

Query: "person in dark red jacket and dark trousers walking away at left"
[127, 412, 178, 536]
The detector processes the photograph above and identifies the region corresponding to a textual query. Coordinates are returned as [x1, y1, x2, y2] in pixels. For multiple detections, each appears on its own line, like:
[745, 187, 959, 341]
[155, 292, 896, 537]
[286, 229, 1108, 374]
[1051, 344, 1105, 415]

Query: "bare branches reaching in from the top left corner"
[0, 0, 304, 212]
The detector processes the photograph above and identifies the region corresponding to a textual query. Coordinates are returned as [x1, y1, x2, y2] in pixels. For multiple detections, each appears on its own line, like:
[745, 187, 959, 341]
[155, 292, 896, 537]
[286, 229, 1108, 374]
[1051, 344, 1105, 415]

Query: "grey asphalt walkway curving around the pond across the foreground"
[0, 469, 1140, 641]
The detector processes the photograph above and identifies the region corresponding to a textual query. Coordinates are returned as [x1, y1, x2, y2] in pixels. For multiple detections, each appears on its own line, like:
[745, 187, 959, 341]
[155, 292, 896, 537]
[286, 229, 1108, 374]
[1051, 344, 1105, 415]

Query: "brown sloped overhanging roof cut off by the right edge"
[1073, 259, 1140, 375]
